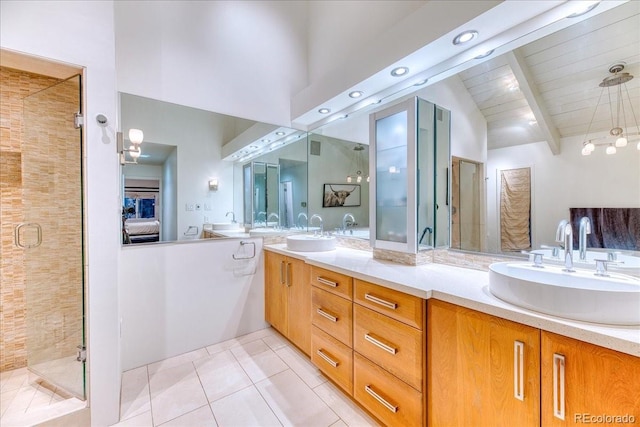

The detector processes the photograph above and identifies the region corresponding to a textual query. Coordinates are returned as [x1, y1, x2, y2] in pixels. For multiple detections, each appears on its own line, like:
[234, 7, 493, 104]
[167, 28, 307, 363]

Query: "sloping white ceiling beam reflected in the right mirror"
[506, 49, 560, 155]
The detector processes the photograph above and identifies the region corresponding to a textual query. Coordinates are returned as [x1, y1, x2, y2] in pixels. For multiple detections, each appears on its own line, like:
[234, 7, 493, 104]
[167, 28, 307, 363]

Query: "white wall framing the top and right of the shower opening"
[0, 0, 120, 426]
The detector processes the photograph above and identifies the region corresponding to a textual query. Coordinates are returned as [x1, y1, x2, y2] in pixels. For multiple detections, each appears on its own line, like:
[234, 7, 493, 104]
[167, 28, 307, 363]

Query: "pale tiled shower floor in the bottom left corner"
[0, 368, 86, 427]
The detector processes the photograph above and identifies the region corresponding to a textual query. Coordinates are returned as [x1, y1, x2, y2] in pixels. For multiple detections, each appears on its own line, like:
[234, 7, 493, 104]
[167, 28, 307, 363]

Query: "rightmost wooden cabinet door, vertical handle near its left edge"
[541, 331, 640, 427]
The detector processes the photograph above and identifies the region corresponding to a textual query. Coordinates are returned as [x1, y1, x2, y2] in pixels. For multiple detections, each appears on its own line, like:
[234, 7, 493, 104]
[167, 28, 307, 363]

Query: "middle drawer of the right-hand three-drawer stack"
[353, 304, 425, 391]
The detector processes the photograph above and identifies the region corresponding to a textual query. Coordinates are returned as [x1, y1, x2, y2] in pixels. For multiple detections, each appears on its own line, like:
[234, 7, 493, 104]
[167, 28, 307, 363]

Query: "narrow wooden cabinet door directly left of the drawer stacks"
[285, 258, 311, 355]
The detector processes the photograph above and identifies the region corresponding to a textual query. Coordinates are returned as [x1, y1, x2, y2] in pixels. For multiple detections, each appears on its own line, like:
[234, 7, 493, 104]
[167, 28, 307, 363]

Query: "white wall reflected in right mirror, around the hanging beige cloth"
[486, 137, 640, 252]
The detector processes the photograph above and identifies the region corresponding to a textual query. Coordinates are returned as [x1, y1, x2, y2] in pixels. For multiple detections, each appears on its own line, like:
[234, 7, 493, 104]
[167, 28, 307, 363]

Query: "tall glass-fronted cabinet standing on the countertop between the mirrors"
[369, 97, 449, 253]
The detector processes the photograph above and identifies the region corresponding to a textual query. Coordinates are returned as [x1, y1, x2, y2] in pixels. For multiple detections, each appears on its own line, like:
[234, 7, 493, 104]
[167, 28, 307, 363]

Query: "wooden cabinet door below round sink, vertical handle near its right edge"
[427, 300, 540, 426]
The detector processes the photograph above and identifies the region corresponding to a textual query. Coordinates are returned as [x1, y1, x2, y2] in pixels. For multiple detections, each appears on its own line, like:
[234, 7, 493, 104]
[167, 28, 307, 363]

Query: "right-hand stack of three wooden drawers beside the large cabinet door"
[353, 279, 426, 426]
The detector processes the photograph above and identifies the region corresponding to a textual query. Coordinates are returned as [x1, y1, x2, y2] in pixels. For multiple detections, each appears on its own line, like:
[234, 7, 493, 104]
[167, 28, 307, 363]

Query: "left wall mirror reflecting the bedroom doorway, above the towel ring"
[120, 93, 307, 245]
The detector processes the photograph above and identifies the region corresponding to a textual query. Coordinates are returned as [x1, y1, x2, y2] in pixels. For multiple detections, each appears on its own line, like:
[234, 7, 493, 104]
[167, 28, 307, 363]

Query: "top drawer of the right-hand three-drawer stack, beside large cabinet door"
[353, 279, 426, 330]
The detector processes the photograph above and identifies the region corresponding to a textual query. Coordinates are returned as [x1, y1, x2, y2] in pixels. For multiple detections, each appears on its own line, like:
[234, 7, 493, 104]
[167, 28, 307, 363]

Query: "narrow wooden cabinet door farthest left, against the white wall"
[264, 251, 288, 336]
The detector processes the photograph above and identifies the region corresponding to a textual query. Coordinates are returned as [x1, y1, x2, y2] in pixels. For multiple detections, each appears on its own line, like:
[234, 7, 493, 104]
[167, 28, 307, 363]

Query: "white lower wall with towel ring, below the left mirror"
[119, 238, 268, 370]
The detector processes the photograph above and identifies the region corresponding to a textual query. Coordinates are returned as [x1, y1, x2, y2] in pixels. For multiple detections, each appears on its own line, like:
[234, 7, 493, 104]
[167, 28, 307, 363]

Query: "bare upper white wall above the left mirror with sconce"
[115, 1, 307, 125]
